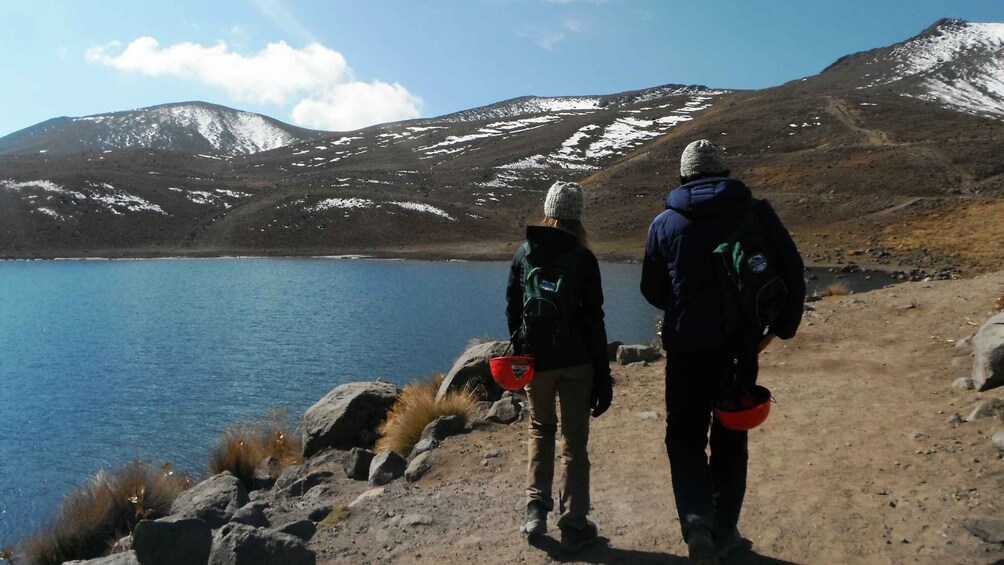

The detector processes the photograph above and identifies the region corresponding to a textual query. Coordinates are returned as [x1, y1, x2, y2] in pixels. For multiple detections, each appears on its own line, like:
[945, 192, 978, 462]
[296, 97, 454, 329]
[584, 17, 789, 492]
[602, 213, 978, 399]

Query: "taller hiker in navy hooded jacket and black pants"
[642, 139, 805, 563]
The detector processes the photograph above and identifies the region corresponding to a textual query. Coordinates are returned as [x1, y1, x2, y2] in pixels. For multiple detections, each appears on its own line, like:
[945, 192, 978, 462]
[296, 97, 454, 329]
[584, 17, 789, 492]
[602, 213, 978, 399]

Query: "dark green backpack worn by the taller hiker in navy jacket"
[714, 198, 788, 335]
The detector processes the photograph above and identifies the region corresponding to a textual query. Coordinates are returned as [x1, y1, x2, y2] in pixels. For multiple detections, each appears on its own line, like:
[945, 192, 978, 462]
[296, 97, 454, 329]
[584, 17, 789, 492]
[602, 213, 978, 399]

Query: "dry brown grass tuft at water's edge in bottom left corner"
[21, 462, 192, 565]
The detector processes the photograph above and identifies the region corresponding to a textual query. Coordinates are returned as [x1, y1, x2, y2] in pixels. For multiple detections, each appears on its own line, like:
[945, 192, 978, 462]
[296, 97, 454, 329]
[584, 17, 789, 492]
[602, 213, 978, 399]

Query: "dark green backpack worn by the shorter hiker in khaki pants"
[517, 247, 579, 355]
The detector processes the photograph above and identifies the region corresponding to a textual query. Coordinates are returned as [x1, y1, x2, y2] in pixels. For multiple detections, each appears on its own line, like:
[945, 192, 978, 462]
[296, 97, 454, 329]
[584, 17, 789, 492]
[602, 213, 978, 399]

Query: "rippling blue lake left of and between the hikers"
[0, 259, 659, 547]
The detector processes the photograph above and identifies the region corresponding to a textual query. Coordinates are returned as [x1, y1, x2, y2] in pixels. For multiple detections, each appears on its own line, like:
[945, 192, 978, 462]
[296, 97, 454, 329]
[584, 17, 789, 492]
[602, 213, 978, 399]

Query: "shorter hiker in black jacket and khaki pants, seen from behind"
[506, 182, 613, 552]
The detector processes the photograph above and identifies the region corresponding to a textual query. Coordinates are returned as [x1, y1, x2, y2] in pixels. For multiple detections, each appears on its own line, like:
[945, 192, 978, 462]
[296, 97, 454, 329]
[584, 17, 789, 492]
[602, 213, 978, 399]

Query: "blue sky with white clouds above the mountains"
[0, 0, 1004, 135]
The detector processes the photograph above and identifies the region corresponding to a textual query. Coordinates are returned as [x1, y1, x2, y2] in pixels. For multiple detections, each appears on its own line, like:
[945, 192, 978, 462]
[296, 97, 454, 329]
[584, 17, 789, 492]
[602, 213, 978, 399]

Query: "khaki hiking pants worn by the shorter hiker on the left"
[526, 364, 592, 529]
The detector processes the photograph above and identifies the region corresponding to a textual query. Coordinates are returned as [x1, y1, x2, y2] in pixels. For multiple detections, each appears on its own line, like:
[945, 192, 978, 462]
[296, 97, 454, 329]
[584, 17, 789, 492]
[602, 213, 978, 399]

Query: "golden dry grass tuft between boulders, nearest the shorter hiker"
[377, 374, 478, 457]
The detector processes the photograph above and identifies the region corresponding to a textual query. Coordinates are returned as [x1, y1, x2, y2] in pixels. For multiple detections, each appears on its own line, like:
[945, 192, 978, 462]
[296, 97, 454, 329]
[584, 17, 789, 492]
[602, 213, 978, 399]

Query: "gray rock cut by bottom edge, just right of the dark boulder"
[209, 524, 317, 565]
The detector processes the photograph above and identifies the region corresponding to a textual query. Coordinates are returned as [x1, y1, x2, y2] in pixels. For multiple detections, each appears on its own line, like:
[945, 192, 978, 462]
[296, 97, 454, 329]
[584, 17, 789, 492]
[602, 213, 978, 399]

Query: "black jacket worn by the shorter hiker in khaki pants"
[505, 226, 609, 374]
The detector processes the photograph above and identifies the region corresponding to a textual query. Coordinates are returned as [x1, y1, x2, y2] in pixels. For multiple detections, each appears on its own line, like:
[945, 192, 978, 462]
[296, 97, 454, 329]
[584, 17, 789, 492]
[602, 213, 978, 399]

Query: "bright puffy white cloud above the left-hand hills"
[86, 37, 422, 129]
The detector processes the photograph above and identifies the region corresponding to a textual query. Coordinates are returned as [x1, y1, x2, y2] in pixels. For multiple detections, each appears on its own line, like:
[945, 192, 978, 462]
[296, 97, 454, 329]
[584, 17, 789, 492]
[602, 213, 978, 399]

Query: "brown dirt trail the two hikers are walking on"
[293, 272, 1004, 564]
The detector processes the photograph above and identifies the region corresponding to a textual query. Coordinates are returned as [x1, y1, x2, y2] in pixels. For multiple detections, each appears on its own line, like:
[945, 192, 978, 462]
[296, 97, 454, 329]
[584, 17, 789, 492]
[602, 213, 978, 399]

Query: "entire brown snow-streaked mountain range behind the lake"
[0, 20, 1004, 272]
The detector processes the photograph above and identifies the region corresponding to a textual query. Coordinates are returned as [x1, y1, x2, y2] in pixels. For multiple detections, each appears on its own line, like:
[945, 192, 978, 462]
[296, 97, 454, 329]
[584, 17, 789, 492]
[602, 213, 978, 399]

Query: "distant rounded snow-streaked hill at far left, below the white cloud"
[0, 102, 317, 157]
